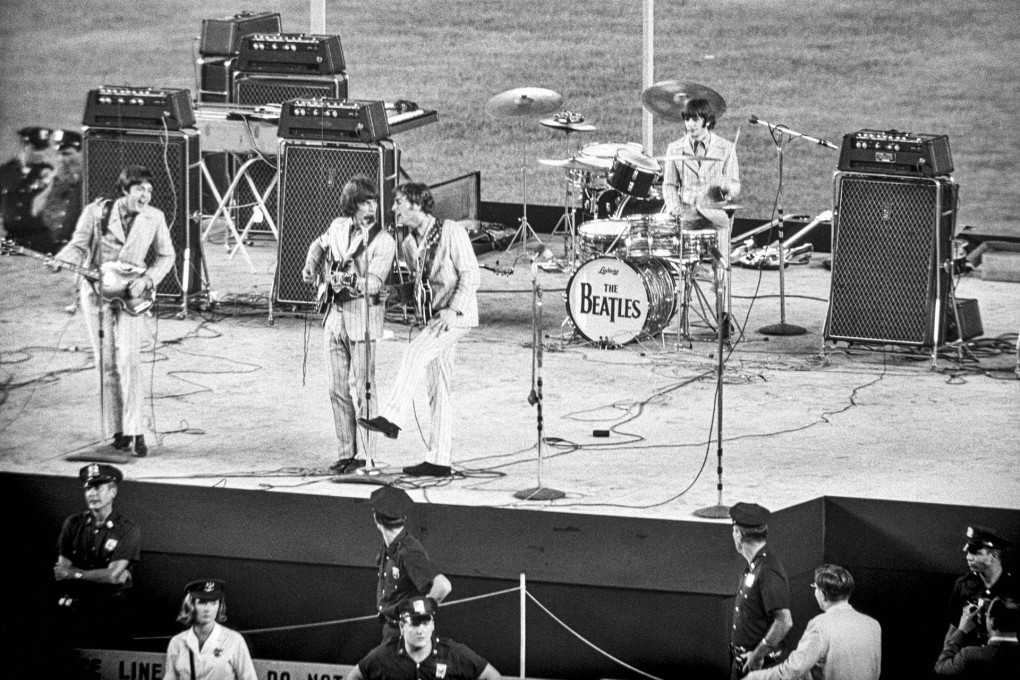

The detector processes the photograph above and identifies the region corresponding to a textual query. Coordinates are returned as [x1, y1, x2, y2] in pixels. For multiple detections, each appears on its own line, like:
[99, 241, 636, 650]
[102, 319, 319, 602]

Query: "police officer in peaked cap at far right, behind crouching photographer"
[944, 524, 1020, 646]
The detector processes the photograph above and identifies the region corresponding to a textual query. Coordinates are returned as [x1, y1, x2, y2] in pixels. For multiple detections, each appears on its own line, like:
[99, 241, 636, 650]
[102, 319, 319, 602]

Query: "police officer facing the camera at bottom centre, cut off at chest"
[346, 596, 501, 680]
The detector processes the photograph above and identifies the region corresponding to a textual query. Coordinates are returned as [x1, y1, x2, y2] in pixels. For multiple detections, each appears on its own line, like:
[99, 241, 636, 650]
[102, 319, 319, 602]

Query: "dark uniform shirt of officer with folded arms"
[57, 511, 142, 596]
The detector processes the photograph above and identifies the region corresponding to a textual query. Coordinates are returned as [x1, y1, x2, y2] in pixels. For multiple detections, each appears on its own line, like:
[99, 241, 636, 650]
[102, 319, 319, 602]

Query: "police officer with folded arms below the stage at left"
[53, 463, 142, 644]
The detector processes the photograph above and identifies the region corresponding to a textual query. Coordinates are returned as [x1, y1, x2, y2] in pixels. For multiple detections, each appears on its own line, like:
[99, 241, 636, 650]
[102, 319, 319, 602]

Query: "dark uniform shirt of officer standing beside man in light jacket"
[730, 545, 789, 649]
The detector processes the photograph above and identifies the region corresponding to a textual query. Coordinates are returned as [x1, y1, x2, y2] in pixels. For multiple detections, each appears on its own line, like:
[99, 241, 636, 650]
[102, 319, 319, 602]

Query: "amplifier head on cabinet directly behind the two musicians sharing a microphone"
[277, 99, 390, 142]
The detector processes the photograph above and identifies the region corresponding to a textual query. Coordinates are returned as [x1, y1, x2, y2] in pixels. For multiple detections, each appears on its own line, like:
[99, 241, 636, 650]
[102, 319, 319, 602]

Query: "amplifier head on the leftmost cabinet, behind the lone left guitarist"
[82, 85, 195, 129]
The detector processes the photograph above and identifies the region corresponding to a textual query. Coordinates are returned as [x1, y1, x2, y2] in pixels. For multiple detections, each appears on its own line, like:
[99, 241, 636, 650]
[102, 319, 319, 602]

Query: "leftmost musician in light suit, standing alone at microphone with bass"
[51, 165, 174, 457]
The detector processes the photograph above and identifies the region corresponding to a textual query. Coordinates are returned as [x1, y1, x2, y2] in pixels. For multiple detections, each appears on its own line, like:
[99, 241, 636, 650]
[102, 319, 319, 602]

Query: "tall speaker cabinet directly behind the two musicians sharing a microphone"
[273, 140, 400, 305]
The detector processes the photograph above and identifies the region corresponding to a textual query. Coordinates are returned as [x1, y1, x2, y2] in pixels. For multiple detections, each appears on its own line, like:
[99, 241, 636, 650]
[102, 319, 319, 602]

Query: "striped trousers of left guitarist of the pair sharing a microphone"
[324, 309, 378, 459]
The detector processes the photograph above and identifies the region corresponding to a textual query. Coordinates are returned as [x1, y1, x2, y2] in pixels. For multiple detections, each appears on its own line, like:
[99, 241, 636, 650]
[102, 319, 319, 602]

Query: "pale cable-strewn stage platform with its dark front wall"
[0, 226, 1020, 677]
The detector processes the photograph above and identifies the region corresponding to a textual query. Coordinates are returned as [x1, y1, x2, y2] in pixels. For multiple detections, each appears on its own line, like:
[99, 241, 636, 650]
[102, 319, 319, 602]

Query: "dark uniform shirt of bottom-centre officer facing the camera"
[358, 638, 489, 680]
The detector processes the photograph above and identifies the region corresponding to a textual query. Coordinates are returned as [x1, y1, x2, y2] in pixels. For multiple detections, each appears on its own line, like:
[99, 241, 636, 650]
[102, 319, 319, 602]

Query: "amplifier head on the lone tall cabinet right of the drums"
[838, 129, 953, 177]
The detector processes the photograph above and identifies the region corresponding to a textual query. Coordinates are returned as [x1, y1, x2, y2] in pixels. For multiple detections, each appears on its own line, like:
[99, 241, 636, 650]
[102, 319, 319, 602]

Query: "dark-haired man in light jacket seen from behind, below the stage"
[747, 565, 882, 680]
